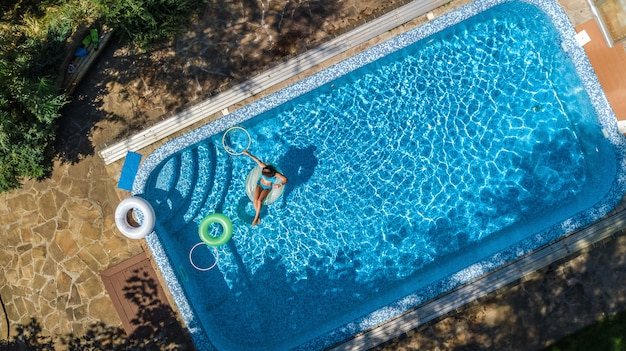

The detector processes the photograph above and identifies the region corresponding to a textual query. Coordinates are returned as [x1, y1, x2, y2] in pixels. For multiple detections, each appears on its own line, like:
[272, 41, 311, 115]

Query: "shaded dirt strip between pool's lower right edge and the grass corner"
[372, 227, 626, 351]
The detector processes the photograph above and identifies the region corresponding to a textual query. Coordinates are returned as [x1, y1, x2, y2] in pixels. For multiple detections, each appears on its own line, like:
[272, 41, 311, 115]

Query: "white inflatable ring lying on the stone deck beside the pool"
[115, 196, 155, 239]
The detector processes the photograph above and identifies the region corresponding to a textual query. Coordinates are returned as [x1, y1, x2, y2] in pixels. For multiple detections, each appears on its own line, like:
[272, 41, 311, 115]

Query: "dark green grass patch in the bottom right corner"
[544, 312, 626, 351]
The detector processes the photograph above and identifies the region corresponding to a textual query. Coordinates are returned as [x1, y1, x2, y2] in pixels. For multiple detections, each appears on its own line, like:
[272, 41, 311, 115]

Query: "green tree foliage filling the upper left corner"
[0, 0, 206, 192]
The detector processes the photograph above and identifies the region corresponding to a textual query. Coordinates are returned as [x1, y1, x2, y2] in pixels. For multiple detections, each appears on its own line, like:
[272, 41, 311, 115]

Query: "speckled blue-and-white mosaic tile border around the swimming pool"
[133, 0, 626, 350]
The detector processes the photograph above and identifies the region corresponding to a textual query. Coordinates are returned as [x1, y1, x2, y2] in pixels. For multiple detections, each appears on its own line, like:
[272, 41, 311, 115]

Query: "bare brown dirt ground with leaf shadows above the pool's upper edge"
[57, 0, 404, 163]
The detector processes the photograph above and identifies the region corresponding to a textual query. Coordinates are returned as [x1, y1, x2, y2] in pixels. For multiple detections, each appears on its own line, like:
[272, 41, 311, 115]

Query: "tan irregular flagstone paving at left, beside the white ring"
[0, 156, 143, 338]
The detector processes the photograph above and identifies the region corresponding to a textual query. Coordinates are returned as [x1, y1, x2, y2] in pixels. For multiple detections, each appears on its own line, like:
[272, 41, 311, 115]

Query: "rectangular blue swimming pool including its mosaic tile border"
[134, 2, 624, 350]
